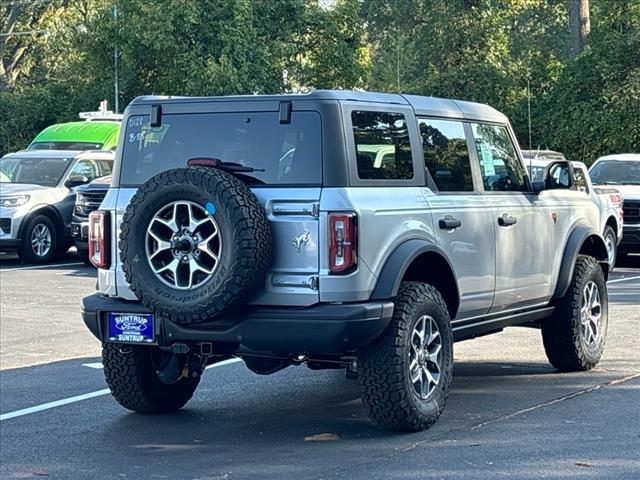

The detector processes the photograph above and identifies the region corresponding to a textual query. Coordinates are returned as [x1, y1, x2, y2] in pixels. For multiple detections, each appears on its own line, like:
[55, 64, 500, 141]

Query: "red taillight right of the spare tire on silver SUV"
[329, 213, 358, 274]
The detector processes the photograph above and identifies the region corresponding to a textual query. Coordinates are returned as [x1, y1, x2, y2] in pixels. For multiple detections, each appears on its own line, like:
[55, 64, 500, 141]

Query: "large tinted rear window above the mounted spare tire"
[120, 112, 322, 185]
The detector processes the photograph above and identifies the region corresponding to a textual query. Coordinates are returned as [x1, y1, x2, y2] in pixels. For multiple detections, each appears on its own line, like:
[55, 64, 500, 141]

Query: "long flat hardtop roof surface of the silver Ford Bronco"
[130, 90, 508, 123]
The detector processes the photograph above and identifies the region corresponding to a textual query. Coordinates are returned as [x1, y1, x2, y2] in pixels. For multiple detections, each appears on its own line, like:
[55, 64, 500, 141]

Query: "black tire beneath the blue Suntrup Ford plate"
[102, 343, 200, 414]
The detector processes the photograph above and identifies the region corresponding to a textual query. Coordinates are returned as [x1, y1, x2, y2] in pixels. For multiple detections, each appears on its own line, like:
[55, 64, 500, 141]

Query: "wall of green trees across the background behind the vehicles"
[0, 0, 640, 162]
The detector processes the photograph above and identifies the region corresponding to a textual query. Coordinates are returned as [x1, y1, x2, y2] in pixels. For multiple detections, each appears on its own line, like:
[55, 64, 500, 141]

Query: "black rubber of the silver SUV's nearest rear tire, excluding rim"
[358, 282, 453, 432]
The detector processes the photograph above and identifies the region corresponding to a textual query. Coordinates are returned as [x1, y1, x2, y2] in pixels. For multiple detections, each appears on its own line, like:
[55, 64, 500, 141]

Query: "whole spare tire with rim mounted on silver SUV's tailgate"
[120, 167, 271, 324]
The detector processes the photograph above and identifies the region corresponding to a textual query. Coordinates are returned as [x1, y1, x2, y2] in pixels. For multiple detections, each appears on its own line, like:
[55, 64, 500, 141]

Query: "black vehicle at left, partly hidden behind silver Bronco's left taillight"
[71, 175, 111, 265]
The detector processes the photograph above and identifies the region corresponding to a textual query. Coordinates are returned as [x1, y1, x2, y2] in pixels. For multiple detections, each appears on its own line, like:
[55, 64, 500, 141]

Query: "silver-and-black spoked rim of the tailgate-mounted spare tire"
[145, 200, 222, 290]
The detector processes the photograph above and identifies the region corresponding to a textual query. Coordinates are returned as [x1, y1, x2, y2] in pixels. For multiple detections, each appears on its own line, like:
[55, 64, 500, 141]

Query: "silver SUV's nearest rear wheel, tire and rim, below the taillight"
[358, 282, 453, 432]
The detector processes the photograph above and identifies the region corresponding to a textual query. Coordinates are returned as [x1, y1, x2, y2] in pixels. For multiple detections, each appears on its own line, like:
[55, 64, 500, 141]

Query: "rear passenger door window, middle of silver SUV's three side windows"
[418, 118, 473, 192]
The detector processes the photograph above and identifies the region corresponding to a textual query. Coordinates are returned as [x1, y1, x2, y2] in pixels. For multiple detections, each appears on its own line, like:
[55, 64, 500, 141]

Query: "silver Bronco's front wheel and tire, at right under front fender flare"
[542, 255, 608, 372]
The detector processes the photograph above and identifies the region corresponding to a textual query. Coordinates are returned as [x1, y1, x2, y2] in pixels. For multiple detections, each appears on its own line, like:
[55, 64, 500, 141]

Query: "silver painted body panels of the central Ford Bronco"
[98, 90, 599, 319]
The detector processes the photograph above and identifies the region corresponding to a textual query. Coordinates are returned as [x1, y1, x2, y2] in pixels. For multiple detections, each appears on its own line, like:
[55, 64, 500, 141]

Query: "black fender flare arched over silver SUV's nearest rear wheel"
[371, 239, 460, 300]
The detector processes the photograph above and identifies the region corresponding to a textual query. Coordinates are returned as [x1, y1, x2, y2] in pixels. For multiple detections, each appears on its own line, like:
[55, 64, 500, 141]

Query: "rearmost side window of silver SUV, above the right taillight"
[351, 111, 413, 180]
